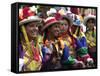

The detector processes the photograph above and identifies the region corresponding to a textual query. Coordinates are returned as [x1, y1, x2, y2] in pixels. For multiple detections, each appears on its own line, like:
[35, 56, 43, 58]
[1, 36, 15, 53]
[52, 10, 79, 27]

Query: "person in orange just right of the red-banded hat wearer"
[59, 15, 84, 68]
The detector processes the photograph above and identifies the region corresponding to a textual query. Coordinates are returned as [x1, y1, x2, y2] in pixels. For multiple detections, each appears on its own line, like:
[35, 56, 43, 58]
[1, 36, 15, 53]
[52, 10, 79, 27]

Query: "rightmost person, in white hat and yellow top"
[84, 15, 96, 64]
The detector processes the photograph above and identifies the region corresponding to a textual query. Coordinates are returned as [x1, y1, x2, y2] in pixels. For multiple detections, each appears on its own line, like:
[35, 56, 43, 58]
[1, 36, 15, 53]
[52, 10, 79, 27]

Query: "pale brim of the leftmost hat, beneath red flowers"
[19, 16, 42, 26]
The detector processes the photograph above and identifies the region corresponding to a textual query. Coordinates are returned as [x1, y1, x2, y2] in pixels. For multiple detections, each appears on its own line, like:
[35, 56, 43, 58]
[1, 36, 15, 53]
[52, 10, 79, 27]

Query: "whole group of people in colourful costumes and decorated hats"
[18, 6, 97, 71]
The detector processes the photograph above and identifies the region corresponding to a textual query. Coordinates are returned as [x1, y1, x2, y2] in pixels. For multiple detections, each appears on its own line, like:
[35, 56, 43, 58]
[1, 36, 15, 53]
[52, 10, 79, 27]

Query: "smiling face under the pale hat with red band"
[49, 23, 60, 37]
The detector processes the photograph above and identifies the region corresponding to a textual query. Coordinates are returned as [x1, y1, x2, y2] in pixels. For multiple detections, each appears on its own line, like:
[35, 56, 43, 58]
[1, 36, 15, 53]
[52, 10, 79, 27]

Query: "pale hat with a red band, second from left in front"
[42, 17, 60, 31]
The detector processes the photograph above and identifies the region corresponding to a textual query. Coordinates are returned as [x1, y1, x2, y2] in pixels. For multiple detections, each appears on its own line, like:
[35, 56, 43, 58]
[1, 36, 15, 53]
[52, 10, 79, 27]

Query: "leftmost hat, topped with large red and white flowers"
[19, 6, 42, 25]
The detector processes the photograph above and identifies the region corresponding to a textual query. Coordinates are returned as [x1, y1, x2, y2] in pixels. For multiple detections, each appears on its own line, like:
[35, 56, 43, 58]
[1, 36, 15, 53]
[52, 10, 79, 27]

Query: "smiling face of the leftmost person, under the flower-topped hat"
[26, 22, 39, 38]
